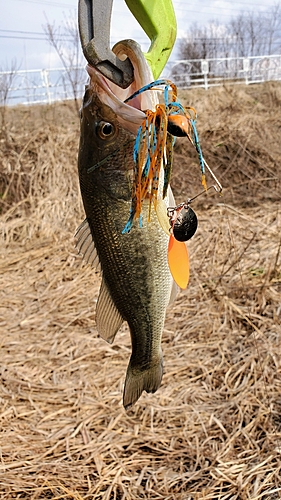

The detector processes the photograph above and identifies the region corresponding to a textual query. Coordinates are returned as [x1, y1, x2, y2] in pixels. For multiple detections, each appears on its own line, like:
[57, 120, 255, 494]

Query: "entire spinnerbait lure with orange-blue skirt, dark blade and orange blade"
[122, 80, 222, 289]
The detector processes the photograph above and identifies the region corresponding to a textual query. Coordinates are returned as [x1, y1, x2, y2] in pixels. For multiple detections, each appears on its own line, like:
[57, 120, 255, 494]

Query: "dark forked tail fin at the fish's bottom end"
[123, 354, 163, 410]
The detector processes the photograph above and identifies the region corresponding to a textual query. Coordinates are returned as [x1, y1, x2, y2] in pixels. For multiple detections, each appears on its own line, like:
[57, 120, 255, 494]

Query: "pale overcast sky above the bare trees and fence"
[0, 0, 276, 69]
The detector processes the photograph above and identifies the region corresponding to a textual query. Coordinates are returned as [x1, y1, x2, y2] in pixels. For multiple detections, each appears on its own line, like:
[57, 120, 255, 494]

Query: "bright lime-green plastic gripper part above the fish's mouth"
[125, 0, 177, 79]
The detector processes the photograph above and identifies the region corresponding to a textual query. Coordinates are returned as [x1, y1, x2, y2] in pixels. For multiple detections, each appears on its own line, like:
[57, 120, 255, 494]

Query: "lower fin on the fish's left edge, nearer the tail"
[96, 279, 123, 344]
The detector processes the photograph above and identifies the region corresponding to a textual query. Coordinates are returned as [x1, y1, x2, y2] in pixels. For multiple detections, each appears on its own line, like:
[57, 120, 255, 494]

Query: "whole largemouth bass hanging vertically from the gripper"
[76, 40, 173, 409]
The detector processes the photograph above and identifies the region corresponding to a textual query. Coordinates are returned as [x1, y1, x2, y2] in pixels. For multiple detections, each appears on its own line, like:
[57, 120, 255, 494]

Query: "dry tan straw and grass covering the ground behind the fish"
[0, 83, 281, 500]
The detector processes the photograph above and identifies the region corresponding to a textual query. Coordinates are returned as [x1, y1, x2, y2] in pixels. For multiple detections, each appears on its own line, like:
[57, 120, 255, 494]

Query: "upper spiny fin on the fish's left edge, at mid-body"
[74, 219, 101, 271]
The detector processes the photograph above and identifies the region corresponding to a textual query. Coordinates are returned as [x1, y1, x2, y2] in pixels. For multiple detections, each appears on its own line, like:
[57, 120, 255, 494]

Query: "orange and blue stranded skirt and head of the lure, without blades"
[122, 79, 207, 234]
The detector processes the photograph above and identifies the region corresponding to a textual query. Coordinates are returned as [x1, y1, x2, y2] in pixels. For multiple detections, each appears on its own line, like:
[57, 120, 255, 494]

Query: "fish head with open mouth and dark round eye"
[79, 40, 157, 179]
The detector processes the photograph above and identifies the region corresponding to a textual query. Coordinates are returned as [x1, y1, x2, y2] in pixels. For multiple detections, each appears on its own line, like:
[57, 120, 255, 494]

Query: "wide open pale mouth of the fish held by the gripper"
[86, 40, 155, 134]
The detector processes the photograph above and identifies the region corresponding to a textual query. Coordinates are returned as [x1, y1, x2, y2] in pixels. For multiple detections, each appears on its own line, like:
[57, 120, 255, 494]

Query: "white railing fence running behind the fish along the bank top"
[0, 55, 281, 105]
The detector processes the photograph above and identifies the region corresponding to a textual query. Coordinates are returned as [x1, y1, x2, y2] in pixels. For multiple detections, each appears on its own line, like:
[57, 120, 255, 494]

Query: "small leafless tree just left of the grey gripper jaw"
[43, 13, 85, 114]
